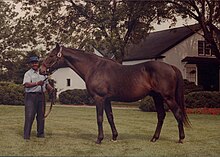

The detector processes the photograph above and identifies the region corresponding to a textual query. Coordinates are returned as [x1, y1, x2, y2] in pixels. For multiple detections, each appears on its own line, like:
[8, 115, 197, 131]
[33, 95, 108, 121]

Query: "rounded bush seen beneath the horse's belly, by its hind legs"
[139, 96, 168, 112]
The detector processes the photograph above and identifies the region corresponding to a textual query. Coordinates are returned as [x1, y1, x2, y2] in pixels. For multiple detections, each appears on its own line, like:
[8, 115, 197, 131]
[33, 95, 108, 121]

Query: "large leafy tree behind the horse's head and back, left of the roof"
[12, 0, 173, 62]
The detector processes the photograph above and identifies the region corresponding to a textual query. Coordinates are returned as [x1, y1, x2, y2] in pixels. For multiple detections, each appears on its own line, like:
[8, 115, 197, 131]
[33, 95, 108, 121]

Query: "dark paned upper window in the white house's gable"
[198, 40, 213, 56]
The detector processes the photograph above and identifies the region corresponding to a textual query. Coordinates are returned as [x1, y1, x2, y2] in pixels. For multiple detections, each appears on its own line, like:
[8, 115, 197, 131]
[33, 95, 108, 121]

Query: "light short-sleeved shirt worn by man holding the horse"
[23, 69, 48, 93]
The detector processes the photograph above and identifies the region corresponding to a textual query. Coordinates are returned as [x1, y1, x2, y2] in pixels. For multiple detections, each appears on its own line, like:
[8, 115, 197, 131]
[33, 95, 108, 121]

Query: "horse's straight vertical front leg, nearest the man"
[95, 97, 104, 144]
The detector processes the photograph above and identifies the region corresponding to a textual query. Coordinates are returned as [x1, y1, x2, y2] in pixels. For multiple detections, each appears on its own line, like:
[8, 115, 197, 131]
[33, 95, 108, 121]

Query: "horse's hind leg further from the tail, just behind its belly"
[151, 94, 166, 142]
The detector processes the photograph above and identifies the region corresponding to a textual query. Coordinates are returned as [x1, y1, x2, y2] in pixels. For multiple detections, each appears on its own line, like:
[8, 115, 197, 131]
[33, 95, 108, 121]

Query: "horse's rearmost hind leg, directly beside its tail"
[165, 98, 185, 143]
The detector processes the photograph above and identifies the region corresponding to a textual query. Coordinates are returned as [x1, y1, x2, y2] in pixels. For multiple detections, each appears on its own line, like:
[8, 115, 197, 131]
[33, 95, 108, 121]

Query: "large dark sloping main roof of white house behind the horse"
[124, 24, 201, 61]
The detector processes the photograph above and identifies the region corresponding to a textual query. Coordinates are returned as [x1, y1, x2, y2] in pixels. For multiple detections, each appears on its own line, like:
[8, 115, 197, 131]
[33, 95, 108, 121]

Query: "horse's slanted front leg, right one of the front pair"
[105, 101, 118, 141]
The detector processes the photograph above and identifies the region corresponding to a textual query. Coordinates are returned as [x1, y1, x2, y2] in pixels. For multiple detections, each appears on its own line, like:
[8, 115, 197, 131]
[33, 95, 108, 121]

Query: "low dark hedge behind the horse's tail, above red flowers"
[185, 91, 220, 108]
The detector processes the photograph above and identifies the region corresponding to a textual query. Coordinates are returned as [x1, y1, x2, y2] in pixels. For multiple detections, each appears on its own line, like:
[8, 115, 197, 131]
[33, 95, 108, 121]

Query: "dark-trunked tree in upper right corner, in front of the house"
[166, 0, 220, 59]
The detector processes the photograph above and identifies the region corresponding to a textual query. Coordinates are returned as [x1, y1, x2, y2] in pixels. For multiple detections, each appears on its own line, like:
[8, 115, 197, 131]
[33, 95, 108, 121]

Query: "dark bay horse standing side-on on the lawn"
[40, 44, 190, 144]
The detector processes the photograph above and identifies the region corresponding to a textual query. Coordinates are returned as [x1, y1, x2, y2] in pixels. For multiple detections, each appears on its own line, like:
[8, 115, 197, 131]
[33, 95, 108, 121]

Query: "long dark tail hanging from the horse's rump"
[172, 66, 191, 127]
